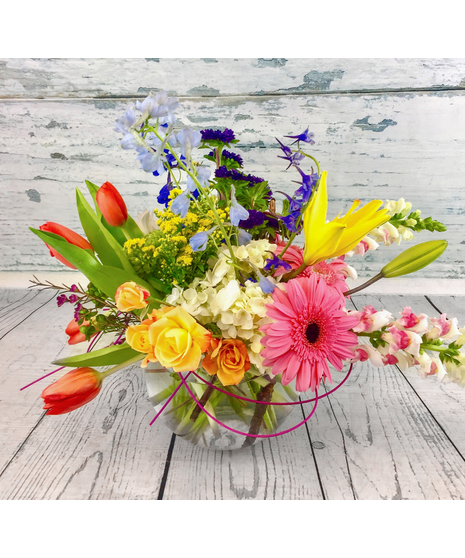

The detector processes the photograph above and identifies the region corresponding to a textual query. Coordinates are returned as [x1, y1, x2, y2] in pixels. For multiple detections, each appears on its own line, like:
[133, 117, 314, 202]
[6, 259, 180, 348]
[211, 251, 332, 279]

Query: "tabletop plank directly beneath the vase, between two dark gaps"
[163, 418, 323, 500]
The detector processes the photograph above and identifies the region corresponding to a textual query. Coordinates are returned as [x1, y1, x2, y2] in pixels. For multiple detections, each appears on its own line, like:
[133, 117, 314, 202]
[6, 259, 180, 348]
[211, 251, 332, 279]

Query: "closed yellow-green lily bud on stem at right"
[380, 240, 447, 277]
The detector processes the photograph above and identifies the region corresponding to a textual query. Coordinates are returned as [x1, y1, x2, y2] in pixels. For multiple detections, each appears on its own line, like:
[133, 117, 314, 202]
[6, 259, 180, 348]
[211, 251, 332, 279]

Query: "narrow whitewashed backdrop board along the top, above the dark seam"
[0, 58, 465, 98]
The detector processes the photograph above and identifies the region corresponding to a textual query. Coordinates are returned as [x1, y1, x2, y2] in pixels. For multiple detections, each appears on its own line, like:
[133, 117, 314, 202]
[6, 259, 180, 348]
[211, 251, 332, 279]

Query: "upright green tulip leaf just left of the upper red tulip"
[76, 188, 135, 273]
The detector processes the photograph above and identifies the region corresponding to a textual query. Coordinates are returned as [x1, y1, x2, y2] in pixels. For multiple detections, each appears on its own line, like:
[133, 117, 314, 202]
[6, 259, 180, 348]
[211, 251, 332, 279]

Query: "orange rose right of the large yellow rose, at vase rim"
[202, 339, 250, 386]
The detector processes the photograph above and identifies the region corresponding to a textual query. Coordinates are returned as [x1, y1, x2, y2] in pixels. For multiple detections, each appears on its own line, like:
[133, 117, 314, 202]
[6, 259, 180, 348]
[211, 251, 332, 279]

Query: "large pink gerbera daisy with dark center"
[260, 273, 358, 391]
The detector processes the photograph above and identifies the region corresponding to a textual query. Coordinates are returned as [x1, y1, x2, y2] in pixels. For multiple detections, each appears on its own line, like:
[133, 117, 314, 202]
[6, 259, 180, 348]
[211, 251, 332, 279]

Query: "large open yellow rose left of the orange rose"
[149, 306, 212, 372]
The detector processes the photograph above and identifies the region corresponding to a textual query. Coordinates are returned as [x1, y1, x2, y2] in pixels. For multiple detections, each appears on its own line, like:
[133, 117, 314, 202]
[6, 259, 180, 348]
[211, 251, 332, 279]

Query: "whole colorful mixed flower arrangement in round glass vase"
[24, 92, 465, 447]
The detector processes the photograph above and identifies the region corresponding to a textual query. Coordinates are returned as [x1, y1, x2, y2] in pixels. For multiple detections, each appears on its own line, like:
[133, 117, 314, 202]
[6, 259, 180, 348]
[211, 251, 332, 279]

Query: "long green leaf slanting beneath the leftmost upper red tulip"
[30, 228, 163, 300]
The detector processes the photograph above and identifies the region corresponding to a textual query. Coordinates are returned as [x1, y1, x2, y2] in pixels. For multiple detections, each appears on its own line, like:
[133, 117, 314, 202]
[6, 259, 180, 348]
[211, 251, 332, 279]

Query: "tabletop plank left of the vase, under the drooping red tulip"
[0, 367, 171, 500]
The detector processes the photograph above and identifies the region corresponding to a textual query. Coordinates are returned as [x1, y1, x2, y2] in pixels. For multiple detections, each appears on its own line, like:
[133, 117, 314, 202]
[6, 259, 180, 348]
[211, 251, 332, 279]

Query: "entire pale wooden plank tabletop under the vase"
[0, 288, 465, 500]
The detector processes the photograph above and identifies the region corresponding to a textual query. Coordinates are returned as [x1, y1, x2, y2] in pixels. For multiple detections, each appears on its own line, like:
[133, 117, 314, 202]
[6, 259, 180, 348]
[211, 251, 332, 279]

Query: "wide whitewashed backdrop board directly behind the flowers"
[0, 91, 465, 278]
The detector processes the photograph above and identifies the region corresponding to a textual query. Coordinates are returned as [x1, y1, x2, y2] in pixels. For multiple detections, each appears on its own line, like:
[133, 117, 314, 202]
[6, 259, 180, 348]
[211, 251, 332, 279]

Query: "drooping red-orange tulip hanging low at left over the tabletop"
[41, 368, 102, 415]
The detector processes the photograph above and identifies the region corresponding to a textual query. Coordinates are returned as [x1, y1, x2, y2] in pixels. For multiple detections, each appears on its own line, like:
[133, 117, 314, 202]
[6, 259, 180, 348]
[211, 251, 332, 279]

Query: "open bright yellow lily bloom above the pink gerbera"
[304, 171, 389, 265]
